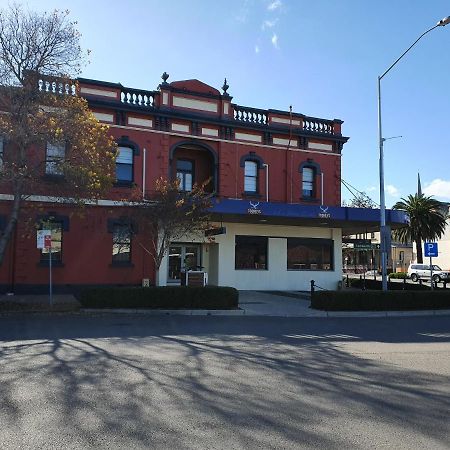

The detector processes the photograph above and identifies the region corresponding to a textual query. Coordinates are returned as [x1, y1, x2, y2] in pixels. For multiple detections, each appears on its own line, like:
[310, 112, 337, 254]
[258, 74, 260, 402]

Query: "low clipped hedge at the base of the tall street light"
[311, 289, 450, 311]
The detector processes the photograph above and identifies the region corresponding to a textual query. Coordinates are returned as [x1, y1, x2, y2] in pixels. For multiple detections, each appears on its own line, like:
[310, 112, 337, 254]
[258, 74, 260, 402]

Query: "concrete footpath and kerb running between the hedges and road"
[0, 291, 450, 318]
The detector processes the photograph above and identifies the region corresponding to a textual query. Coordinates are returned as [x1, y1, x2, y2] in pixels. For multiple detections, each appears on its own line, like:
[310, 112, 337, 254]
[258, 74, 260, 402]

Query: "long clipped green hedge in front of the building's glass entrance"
[79, 286, 239, 309]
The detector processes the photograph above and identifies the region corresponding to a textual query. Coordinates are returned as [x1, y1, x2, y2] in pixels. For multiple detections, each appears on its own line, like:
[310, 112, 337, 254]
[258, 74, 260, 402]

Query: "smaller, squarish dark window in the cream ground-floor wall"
[235, 236, 267, 270]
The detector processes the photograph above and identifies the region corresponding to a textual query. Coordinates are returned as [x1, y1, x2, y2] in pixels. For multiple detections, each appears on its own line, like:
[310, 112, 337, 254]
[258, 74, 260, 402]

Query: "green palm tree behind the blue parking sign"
[393, 194, 448, 263]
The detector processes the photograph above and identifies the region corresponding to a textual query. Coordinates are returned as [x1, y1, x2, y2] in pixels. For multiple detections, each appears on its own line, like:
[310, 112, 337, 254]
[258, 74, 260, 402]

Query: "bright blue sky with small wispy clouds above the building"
[22, 0, 450, 206]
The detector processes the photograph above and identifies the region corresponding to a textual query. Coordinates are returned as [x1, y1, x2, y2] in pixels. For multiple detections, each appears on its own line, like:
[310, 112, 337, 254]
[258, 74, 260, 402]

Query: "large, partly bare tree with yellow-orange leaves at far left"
[0, 6, 117, 263]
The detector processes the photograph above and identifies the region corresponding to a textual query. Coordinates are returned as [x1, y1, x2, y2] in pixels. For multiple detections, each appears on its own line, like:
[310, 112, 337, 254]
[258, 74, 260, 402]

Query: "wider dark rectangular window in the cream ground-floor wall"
[287, 238, 333, 270]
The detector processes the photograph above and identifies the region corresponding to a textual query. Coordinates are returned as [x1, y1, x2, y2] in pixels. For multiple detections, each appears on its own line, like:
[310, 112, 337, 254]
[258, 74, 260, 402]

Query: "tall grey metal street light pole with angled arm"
[378, 16, 450, 291]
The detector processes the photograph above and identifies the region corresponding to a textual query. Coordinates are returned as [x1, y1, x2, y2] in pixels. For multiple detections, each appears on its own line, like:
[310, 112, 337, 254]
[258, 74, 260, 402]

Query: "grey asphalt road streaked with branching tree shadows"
[0, 315, 450, 450]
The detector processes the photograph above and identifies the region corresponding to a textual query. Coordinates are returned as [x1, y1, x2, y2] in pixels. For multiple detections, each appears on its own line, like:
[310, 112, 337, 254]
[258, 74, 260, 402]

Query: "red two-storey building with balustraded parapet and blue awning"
[0, 73, 406, 291]
